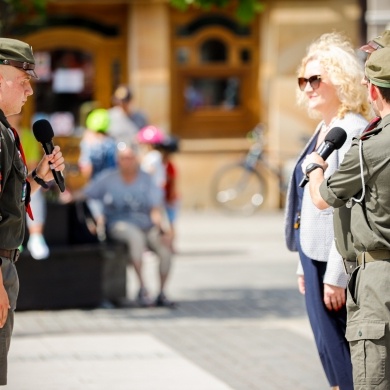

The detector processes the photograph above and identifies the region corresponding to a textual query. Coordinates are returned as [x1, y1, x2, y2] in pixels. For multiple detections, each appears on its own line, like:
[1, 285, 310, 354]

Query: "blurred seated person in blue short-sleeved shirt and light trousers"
[83, 142, 175, 308]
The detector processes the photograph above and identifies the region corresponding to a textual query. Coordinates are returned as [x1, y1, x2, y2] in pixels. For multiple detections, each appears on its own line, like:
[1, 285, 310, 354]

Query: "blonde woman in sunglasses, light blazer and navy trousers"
[285, 33, 371, 390]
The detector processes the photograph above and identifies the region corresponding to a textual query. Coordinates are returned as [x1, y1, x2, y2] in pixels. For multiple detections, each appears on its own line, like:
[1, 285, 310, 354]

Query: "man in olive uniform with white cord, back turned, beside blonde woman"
[302, 47, 390, 390]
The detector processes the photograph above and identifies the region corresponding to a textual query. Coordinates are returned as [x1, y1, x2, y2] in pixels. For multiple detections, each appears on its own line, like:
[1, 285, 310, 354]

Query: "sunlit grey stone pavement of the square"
[8, 211, 329, 390]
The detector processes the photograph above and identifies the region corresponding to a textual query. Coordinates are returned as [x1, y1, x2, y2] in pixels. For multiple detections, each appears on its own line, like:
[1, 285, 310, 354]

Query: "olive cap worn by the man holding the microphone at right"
[365, 47, 390, 88]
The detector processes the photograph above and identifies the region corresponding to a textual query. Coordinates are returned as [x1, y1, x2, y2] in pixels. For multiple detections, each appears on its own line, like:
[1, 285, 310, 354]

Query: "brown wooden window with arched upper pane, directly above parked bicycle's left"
[171, 13, 259, 138]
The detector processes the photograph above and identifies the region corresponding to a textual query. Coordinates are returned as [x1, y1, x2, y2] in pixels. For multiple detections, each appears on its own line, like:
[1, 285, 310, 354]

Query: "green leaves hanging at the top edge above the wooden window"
[170, 0, 264, 24]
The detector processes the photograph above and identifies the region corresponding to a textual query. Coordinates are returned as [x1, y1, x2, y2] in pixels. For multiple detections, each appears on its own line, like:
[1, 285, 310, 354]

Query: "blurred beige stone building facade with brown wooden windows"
[18, 0, 365, 209]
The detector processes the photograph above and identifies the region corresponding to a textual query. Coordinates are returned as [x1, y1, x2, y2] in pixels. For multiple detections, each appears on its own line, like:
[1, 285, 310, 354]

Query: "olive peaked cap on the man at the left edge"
[0, 38, 38, 78]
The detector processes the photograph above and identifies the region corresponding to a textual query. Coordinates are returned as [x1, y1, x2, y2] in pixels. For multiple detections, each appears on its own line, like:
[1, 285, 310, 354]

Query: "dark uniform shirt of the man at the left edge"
[0, 124, 27, 249]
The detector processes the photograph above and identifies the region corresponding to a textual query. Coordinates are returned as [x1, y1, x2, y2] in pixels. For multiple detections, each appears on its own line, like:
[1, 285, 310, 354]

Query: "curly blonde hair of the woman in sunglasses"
[297, 32, 373, 120]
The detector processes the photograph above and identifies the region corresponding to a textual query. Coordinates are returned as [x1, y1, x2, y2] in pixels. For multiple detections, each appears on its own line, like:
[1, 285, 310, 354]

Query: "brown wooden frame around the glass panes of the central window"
[171, 12, 259, 138]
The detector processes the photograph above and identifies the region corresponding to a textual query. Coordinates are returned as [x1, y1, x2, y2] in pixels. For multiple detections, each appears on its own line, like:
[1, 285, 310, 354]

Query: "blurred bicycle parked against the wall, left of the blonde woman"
[211, 123, 286, 215]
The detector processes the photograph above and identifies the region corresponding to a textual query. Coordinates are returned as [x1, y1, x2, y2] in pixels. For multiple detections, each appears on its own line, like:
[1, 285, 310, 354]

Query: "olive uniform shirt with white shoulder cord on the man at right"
[320, 115, 390, 252]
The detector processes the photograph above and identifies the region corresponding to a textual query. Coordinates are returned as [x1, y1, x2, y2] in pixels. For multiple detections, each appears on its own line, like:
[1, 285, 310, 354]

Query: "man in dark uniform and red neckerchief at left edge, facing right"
[0, 38, 65, 386]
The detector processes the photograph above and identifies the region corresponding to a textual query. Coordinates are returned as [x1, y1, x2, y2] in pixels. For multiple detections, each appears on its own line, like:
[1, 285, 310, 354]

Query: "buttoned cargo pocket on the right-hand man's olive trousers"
[345, 320, 386, 385]
